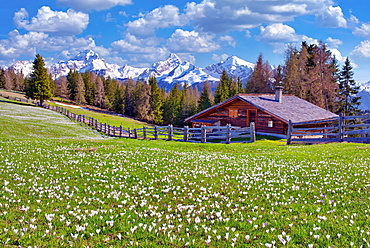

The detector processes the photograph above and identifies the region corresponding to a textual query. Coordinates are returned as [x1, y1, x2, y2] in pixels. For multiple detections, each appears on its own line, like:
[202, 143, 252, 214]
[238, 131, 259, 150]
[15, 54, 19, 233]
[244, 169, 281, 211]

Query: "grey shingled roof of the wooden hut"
[185, 94, 338, 123]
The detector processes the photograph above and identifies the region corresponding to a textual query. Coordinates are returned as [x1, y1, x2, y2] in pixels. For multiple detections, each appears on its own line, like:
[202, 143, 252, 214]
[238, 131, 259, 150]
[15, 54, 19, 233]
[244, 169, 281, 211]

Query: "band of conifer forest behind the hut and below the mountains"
[0, 42, 360, 126]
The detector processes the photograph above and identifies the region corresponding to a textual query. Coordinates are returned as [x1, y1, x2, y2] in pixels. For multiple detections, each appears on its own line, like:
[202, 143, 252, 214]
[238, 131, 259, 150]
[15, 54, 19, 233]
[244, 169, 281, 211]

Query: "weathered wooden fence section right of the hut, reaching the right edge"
[287, 114, 370, 145]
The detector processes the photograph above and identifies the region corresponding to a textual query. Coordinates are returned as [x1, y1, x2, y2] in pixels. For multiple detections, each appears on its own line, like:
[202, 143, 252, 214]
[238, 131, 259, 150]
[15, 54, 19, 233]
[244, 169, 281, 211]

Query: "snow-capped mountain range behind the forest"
[5, 50, 370, 110]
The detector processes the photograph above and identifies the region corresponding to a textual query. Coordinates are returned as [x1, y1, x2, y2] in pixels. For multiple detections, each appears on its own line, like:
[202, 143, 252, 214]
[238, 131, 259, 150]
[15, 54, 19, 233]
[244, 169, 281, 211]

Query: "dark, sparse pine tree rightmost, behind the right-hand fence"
[338, 57, 361, 116]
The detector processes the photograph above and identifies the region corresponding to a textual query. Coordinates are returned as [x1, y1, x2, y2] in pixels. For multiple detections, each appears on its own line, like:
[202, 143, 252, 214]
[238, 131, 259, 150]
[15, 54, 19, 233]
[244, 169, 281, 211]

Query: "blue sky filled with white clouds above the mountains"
[0, 0, 370, 83]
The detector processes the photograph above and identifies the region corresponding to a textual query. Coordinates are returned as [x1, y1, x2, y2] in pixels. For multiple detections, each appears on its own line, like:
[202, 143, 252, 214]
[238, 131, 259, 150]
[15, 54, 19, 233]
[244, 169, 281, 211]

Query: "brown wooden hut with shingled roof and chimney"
[185, 87, 338, 135]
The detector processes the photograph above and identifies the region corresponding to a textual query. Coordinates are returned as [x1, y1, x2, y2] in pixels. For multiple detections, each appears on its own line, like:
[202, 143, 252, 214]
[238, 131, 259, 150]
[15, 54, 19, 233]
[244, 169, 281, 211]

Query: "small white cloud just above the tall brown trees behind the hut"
[257, 23, 300, 42]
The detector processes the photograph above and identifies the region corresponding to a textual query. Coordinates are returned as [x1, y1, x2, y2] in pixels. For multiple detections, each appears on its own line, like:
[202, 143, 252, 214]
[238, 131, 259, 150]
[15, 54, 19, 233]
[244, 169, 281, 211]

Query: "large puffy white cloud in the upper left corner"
[13, 6, 89, 36]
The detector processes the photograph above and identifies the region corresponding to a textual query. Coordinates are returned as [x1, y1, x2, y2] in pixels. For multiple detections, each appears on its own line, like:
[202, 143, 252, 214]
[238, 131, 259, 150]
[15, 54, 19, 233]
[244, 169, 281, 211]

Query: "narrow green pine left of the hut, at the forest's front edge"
[149, 77, 163, 124]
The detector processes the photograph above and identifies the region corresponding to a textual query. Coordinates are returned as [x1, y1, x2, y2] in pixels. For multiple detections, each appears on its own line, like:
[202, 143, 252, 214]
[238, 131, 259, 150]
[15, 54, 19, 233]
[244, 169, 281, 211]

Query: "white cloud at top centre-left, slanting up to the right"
[126, 5, 187, 37]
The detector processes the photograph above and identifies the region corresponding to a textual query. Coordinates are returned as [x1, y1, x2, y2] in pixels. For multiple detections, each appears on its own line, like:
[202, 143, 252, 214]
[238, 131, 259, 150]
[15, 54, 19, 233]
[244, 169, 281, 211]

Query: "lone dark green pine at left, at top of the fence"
[26, 54, 53, 106]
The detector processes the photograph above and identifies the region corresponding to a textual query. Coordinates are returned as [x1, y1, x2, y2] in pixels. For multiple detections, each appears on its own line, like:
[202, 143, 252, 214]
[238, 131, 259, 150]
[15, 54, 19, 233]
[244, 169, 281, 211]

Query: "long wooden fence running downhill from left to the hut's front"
[43, 104, 256, 144]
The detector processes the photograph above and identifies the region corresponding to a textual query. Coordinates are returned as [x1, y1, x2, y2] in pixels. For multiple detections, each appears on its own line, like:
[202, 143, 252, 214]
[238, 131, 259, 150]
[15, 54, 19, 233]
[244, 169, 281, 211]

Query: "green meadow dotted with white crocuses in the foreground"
[0, 101, 370, 247]
